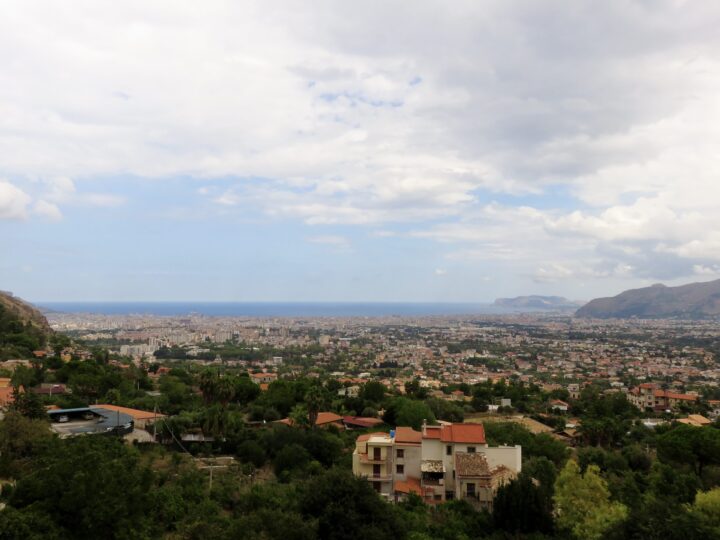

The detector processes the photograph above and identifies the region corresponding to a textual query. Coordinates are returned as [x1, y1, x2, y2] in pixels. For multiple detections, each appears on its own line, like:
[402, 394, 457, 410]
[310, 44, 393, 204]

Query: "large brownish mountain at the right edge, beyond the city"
[575, 279, 720, 319]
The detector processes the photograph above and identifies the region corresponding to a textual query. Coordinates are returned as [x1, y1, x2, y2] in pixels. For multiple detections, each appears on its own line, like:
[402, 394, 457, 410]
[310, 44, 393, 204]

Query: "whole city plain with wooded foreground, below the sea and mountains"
[0, 296, 720, 539]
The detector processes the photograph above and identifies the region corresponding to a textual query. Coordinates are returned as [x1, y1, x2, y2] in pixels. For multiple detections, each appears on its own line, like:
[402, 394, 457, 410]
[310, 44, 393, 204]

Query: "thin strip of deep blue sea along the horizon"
[39, 302, 512, 317]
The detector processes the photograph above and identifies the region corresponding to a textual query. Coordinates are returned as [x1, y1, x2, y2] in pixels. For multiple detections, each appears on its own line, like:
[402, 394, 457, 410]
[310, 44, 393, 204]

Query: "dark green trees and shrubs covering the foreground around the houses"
[0, 338, 720, 540]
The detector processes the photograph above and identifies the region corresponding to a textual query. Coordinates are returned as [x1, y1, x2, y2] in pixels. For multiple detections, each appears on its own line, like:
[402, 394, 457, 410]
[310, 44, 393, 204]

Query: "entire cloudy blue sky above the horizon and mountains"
[0, 0, 720, 302]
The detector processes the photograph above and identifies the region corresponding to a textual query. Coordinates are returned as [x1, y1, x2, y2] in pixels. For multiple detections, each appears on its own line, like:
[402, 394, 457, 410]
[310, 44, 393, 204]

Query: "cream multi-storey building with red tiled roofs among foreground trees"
[353, 424, 522, 510]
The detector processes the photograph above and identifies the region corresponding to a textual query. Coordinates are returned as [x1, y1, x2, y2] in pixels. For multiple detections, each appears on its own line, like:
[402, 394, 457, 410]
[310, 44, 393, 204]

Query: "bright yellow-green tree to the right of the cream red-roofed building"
[554, 460, 628, 540]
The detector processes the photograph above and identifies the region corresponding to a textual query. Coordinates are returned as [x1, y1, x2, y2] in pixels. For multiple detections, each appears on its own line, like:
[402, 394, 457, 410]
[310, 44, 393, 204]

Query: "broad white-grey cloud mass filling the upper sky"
[0, 0, 720, 294]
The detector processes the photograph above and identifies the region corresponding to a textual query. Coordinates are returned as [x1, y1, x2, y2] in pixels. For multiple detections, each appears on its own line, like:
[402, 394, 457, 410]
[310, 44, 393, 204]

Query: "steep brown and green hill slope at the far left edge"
[0, 292, 52, 360]
